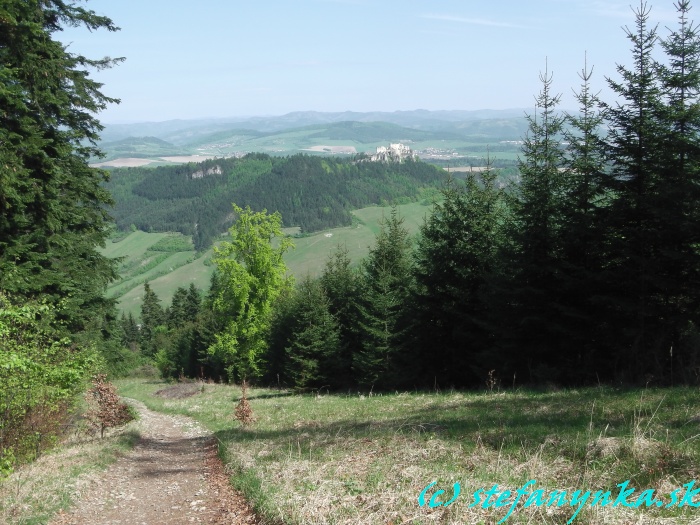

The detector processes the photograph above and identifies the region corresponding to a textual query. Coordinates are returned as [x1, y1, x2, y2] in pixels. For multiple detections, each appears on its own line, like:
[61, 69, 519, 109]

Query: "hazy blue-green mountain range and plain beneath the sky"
[94, 109, 527, 165]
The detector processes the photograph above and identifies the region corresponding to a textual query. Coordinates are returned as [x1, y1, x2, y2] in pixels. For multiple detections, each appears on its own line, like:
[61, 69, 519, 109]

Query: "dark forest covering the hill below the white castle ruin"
[106, 154, 452, 250]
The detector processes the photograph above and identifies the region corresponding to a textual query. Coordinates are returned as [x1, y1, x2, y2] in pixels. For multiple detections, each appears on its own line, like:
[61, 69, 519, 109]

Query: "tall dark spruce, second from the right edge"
[606, 2, 673, 379]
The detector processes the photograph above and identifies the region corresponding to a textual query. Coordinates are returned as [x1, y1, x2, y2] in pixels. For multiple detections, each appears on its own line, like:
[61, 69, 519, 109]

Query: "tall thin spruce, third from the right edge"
[558, 56, 609, 376]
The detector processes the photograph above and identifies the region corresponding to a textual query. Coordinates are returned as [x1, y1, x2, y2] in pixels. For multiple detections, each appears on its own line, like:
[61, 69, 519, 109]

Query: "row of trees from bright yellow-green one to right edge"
[138, 0, 700, 389]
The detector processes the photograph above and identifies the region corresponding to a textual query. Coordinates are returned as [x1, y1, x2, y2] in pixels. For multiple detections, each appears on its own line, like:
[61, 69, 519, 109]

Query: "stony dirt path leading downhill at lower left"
[51, 400, 258, 525]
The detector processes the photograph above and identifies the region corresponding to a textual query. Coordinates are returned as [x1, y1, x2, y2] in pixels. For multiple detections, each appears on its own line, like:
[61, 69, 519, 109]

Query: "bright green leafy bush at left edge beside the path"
[0, 293, 100, 477]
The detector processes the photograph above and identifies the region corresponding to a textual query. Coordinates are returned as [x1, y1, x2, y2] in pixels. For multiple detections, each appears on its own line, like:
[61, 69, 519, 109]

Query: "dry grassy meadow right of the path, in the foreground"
[119, 380, 700, 525]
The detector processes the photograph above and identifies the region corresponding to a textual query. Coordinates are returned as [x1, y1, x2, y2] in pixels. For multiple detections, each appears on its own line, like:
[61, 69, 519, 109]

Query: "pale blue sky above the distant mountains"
[55, 0, 684, 123]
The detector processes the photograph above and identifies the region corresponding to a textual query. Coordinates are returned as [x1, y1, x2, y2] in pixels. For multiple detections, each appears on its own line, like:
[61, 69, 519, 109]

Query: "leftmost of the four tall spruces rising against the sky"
[501, 62, 567, 380]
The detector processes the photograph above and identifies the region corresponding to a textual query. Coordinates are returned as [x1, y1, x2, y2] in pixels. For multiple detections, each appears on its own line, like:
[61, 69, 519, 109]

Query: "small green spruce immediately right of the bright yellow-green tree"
[285, 277, 342, 388]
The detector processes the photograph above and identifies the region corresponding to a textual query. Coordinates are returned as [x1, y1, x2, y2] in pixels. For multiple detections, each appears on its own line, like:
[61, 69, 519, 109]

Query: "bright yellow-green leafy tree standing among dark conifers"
[210, 204, 293, 381]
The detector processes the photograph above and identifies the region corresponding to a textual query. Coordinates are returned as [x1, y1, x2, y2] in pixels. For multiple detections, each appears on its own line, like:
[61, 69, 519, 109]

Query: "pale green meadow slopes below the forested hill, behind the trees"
[103, 203, 430, 315]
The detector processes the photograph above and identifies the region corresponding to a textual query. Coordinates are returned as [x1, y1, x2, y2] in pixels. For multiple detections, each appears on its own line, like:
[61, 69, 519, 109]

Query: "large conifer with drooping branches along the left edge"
[0, 0, 122, 332]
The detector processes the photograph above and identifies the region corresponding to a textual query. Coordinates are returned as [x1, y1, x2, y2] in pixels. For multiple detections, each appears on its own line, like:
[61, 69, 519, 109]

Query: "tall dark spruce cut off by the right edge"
[656, 0, 700, 381]
